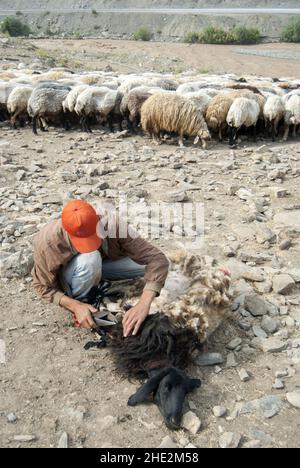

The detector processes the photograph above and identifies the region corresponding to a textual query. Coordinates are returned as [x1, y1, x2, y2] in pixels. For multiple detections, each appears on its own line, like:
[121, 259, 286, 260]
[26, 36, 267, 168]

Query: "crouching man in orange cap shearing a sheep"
[32, 200, 169, 337]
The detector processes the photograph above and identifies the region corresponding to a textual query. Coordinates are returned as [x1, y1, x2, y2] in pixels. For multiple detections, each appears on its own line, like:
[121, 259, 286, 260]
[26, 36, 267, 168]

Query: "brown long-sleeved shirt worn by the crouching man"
[32, 220, 169, 305]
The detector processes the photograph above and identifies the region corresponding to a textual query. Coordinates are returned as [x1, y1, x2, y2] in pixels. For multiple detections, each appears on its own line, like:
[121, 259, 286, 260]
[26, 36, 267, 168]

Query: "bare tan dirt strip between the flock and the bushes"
[0, 39, 300, 78]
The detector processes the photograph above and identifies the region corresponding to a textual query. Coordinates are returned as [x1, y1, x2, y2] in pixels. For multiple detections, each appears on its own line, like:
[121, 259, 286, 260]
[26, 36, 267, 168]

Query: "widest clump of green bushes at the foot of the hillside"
[184, 26, 261, 44]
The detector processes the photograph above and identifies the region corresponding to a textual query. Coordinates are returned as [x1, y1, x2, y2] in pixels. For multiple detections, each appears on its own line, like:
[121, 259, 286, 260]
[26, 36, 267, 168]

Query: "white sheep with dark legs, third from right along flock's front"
[226, 97, 260, 145]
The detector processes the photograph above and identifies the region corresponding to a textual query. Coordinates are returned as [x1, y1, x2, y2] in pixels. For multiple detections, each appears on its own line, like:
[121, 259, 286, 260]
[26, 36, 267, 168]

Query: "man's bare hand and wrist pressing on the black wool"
[123, 291, 156, 338]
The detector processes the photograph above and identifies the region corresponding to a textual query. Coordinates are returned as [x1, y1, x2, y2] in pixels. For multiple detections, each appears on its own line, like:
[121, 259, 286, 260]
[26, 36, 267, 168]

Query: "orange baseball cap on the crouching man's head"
[61, 200, 102, 253]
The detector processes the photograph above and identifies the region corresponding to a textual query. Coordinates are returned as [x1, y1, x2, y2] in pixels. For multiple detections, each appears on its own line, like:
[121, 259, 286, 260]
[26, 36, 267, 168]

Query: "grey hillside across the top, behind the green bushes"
[0, 0, 299, 41]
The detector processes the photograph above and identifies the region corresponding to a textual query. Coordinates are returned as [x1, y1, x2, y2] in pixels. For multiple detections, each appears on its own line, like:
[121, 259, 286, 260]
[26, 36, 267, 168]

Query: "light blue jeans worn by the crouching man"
[60, 251, 145, 300]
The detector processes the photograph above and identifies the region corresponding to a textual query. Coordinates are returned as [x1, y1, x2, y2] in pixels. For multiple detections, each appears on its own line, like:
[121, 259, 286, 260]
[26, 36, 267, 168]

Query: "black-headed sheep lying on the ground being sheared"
[102, 254, 231, 429]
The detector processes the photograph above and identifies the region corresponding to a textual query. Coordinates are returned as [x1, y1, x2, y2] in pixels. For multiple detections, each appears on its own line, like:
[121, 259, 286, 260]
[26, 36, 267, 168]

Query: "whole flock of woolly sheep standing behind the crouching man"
[0, 66, 300, 148]
